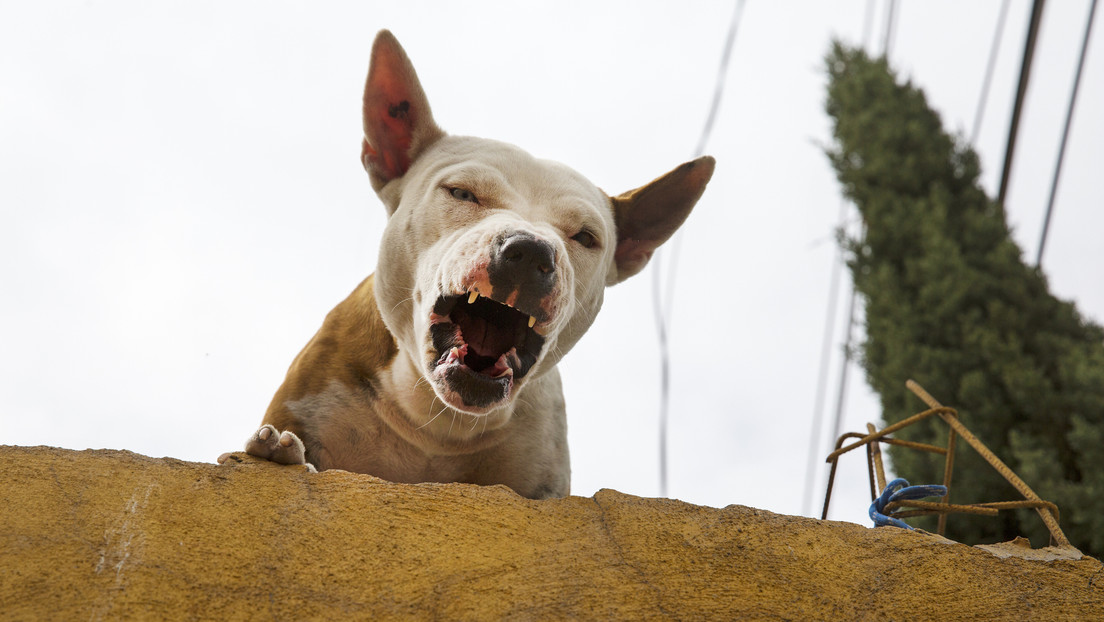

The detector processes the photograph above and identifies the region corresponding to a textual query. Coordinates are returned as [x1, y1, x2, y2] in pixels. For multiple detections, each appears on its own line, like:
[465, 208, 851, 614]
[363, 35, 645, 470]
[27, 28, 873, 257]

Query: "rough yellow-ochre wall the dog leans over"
[0, 447, 1104, 620]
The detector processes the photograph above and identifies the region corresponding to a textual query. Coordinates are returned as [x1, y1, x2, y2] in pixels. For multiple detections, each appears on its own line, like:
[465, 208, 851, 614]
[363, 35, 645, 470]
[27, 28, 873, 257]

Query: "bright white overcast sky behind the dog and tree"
[0, 0, 1104, 524]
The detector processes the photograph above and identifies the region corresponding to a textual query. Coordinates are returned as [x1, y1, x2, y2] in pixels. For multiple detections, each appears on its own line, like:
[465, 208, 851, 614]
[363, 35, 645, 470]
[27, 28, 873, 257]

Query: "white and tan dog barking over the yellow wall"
[219, 30, 714, 498]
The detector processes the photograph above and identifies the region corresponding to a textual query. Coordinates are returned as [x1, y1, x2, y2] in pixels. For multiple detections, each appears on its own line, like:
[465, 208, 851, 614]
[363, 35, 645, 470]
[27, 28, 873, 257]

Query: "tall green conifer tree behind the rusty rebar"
[827, 43, 1104, 557]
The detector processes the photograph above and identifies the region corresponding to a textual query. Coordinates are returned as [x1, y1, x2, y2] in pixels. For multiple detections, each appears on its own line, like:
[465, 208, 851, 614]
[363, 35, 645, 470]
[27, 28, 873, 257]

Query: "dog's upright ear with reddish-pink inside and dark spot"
[360, 30, 444, 192]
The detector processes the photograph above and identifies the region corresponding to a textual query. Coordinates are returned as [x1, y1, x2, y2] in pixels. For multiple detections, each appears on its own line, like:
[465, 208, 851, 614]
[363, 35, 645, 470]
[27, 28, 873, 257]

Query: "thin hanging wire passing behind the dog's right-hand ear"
[651, 0, 746, 497]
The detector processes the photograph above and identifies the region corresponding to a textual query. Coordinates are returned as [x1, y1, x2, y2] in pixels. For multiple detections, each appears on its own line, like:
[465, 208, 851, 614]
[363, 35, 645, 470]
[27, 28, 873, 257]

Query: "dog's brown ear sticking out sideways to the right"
[608, 156, 716, 285]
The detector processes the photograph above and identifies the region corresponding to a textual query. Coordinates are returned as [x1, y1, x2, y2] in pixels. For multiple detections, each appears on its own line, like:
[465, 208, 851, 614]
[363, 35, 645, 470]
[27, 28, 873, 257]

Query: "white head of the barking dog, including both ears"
[361, 31, 713, 414]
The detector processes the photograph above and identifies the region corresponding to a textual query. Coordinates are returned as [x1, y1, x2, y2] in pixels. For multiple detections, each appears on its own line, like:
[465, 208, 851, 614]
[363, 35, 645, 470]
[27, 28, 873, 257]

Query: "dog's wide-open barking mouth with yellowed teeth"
[429, 291, 544, 409]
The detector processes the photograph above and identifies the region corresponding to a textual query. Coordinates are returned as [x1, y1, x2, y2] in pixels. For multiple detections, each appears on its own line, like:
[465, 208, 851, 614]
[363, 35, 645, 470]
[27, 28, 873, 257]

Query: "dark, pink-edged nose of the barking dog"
[487, 233, 556, 308]
